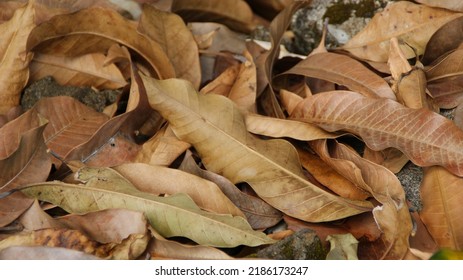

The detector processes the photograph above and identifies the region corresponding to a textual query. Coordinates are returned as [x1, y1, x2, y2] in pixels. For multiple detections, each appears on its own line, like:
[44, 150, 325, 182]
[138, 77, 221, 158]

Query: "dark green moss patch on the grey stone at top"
[323, 0, 376, 24]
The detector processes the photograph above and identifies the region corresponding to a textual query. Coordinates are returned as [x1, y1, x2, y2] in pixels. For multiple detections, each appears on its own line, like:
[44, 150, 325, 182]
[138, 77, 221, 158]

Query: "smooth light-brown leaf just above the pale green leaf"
[113, 163, 245, 217]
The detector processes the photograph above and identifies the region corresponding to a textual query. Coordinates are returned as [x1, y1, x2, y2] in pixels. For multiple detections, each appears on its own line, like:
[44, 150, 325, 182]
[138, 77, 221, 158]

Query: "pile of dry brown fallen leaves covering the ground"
[0, 0, 463, 259]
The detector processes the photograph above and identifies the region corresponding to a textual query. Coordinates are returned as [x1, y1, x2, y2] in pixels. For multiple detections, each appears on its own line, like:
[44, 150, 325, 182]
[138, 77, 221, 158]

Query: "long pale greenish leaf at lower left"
[22, 168, 273, 247]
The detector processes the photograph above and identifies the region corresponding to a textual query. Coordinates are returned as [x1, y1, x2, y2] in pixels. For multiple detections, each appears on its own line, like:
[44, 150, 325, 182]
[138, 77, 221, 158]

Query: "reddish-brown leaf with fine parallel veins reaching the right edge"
[291, 91, 463, 176]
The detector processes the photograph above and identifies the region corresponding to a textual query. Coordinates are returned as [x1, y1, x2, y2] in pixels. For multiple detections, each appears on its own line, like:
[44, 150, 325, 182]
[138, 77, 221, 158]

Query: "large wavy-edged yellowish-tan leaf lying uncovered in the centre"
[142, 76, 371, 221]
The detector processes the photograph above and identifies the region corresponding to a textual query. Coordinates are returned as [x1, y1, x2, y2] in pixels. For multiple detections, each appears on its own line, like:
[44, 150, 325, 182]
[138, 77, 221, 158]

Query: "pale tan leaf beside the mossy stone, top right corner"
[342, 1, 461, 62]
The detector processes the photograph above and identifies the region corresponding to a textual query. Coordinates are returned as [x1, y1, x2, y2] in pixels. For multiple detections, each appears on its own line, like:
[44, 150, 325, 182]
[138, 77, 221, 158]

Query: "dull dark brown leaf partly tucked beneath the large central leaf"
[179, 151, 281, 229]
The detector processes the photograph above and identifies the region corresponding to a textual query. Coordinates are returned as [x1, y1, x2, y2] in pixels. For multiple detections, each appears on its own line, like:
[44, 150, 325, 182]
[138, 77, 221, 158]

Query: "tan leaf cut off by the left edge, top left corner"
[0, 1, 35, 114]
